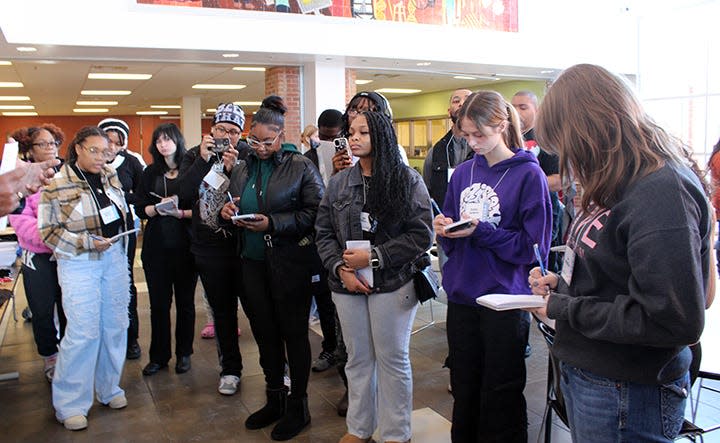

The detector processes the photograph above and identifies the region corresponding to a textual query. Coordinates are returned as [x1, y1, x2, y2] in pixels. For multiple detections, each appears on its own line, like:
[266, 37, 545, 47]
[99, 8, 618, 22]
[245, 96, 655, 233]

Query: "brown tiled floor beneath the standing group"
[0, 250, 720, 443]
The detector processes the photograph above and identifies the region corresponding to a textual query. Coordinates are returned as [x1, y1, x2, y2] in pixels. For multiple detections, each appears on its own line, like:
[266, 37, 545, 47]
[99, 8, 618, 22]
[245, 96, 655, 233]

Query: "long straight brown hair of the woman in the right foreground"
[535, 64, 703, 210]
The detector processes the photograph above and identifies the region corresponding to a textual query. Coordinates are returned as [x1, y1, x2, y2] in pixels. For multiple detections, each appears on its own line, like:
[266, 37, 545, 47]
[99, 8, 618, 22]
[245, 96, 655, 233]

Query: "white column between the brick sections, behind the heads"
[302, 59, 345, 128]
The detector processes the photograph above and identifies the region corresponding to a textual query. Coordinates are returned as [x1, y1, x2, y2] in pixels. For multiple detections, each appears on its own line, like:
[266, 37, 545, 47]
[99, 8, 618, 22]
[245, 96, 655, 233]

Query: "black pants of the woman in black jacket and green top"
[240, 247, 312, 399]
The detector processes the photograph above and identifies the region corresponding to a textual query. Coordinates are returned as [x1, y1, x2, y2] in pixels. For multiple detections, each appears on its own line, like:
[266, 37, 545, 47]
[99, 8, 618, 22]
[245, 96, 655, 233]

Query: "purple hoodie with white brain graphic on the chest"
[438, 150, 552, 306]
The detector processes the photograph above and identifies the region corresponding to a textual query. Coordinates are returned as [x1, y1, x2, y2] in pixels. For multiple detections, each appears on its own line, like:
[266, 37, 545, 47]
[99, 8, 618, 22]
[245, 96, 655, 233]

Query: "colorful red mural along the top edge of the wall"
[137, 0, 518, 32]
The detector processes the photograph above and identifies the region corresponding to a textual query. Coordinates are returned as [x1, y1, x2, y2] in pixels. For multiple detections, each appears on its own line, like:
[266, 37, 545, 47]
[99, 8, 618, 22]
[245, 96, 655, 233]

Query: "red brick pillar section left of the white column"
[265, 66, 302, 148]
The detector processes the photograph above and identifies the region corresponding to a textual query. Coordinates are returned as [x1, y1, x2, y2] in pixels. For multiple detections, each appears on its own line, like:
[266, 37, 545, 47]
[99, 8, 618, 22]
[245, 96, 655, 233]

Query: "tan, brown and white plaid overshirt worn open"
[38, 163, 127, 260]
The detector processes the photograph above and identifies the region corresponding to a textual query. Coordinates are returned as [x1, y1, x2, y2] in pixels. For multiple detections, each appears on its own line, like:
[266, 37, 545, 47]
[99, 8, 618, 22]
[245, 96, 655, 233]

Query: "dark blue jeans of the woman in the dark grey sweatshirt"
[560, 363, 690, 443]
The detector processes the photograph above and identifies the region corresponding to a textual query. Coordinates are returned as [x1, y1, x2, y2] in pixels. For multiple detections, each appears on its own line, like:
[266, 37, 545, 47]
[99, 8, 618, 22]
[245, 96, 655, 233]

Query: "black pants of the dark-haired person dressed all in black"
[143, 250, 197, 364]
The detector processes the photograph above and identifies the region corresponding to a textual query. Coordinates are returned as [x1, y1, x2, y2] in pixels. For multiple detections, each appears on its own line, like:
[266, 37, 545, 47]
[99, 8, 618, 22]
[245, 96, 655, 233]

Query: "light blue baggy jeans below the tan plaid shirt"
[52, 242, 130, 421]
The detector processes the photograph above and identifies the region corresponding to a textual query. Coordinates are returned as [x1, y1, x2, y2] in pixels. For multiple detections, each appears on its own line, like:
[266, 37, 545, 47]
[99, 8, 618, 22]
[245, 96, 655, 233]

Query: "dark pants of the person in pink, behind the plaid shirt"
[22, 254, 67, 357]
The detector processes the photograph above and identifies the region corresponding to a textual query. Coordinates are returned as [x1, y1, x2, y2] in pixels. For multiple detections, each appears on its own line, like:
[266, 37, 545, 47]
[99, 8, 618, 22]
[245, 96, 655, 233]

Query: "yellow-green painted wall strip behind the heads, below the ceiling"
[389, 80, 545, 120]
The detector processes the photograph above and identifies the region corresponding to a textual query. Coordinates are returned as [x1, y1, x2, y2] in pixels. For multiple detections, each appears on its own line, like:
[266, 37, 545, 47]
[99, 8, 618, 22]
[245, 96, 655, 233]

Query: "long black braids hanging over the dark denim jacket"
[361, 111, 412, 223]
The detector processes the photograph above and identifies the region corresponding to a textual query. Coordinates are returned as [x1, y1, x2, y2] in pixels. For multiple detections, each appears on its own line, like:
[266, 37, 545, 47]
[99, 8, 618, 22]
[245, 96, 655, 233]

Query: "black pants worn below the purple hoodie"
[447, 302, 529, 443]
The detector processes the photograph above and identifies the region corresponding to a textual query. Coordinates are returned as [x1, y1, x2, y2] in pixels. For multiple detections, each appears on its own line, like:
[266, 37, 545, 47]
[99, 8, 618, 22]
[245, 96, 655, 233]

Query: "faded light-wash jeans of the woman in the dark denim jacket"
[332, 281, 418, 441]
